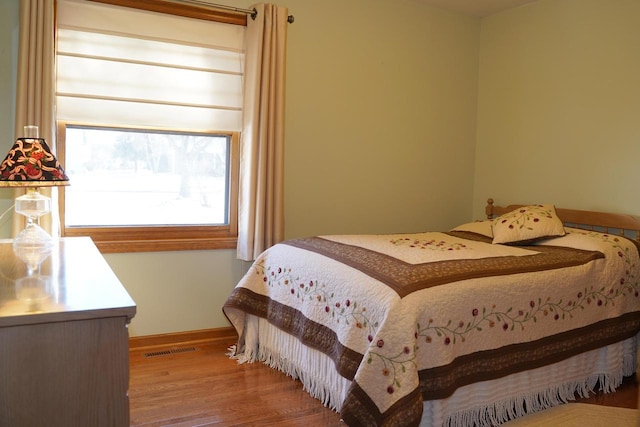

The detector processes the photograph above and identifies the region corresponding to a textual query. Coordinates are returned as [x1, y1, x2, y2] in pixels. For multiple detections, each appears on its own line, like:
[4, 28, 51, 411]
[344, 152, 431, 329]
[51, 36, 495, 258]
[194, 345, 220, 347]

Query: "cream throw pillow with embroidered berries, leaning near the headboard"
[491, 205, 565, 245]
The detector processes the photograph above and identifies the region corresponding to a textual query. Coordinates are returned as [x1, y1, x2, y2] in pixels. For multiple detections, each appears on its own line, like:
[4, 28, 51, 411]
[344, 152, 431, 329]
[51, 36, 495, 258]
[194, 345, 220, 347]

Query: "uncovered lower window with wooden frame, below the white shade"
[58, 123, 238, 252]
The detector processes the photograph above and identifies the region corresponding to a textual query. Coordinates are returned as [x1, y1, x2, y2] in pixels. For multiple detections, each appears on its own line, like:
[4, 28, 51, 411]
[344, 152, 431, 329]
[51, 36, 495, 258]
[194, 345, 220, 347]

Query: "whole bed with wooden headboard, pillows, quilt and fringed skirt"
[223, 199, 640, 426]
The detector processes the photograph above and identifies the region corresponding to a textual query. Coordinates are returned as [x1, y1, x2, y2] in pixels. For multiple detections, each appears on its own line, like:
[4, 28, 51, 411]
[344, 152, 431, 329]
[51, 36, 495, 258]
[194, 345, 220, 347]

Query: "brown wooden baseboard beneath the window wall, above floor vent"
[129, 327, 238, 350]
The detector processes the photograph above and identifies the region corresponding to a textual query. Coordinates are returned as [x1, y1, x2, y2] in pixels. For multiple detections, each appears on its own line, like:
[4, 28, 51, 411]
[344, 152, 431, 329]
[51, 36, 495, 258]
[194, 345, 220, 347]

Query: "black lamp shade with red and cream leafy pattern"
[0, 137, 69, 187]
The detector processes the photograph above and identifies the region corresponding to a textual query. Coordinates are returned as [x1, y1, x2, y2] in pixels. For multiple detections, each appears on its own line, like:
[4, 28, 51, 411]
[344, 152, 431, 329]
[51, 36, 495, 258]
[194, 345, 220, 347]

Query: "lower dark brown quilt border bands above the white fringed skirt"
[223, 288, 640, 402]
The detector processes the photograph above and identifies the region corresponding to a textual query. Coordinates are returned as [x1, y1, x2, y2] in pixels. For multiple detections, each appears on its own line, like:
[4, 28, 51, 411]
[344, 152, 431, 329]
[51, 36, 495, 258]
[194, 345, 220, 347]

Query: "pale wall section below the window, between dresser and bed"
[105, 250, 246, 336]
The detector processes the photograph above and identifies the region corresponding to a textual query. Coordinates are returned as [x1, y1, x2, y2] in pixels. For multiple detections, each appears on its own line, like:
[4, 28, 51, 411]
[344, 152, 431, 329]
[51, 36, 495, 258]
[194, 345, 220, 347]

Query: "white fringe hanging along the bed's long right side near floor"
[444, 354, 636, 427]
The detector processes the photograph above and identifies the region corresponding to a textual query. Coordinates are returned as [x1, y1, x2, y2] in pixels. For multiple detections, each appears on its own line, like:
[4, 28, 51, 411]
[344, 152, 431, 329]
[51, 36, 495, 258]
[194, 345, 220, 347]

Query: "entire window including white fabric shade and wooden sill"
[56, 0, 244, 252]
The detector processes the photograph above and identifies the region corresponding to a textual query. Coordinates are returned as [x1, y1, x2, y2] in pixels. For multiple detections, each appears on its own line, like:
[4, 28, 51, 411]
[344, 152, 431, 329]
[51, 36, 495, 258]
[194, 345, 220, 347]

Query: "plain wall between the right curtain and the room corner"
[281, 0, 480, 237]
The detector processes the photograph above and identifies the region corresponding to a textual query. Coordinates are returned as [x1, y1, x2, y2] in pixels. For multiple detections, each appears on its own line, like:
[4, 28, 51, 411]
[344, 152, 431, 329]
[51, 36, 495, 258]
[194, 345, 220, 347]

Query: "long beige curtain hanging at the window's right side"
[237, 4, 288, 261]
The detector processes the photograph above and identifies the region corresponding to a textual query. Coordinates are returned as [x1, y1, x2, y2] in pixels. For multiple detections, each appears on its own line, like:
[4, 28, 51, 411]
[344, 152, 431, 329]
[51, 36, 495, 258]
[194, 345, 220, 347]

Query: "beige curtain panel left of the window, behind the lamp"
[13, 0, 59, 235]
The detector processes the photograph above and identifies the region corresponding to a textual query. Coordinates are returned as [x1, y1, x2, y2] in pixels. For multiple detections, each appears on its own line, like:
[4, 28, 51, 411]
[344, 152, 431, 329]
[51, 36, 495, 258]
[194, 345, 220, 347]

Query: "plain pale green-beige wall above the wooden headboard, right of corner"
[474, 0, 640, 217]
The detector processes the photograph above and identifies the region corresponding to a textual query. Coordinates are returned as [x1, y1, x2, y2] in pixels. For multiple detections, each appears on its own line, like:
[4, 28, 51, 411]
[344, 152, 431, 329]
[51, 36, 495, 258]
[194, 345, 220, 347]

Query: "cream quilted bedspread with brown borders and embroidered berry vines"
[223, 228, 640, 426]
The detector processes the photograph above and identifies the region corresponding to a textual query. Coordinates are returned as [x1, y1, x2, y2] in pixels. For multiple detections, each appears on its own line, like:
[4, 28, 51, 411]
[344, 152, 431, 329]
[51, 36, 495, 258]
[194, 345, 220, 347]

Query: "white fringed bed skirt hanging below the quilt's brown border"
[228, 316, 640, 427]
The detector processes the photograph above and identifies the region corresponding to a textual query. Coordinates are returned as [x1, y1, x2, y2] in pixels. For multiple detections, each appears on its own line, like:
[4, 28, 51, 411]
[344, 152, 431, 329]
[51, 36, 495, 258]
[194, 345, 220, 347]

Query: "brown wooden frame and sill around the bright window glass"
[56, 121, 240, 253]
